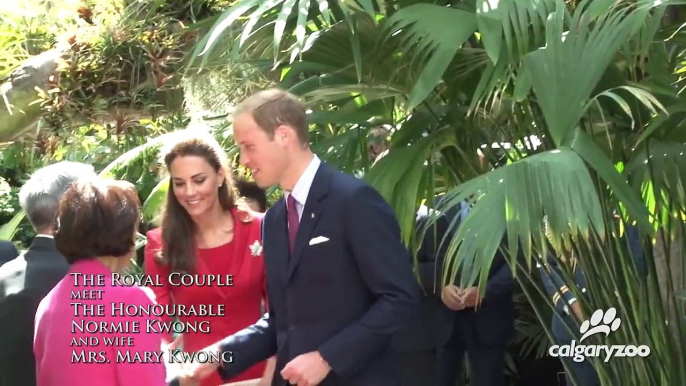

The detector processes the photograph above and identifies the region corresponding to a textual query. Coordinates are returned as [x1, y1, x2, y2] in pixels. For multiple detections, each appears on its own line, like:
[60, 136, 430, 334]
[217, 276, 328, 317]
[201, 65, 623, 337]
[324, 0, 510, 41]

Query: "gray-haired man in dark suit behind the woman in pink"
[0, 162, 95, 386]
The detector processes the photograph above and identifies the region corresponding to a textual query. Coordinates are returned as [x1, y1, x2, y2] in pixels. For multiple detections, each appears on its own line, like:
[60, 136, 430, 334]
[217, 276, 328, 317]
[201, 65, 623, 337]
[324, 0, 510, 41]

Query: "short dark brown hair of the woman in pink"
[53, 178, 140, 264]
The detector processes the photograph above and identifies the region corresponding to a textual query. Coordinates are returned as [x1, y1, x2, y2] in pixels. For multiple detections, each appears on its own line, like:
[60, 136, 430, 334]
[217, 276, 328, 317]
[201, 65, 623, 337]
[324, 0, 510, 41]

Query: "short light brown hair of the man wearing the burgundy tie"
[238, 88, 309, 147]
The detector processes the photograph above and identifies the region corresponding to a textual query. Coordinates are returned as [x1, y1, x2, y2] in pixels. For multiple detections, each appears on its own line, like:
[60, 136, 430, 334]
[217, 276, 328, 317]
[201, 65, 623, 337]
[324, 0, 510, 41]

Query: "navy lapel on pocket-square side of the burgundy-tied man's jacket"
[285, 162, 333, 283]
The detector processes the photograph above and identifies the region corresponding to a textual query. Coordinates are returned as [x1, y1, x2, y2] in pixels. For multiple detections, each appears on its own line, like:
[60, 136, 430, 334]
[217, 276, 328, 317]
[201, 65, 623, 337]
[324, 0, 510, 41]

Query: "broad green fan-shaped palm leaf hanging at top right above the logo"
[523, 2, 660, 146]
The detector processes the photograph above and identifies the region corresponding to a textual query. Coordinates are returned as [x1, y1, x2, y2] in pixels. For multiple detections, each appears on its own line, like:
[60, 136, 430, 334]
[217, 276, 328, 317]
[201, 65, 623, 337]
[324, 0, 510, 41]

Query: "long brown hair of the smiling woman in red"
[157, 133, 243, 273]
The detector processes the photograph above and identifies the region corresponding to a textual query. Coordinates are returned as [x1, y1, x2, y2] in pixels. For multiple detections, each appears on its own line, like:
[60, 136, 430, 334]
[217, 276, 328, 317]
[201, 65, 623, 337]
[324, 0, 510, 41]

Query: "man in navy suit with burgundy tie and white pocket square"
[191, 90, 419, 386]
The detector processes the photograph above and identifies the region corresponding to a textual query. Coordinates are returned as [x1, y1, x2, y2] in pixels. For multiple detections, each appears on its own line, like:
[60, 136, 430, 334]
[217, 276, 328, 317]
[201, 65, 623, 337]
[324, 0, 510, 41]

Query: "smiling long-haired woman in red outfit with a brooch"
[144, 134, 271, 386]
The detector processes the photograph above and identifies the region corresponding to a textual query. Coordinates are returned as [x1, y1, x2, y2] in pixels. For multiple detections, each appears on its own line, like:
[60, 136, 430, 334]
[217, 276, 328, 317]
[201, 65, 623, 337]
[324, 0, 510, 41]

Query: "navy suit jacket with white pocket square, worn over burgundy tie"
[220, 162, 419, 386]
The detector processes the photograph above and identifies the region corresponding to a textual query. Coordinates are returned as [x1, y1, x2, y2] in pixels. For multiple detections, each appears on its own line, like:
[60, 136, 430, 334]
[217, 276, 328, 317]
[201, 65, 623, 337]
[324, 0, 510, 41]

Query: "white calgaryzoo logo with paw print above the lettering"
[548, 307, 650, 362]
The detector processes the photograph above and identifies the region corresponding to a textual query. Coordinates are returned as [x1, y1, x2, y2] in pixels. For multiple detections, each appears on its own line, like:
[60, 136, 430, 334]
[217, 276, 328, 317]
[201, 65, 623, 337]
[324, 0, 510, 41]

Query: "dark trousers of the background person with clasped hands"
[437, 328, 507, 386]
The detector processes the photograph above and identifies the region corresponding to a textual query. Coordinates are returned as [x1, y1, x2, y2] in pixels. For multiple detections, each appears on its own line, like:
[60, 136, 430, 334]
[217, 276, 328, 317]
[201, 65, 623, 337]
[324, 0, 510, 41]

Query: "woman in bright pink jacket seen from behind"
[34, 179, 194, 386]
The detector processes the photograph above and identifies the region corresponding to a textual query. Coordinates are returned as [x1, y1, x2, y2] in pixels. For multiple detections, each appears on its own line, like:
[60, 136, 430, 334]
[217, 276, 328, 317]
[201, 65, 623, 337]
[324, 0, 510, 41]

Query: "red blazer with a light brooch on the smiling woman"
[144, 208, 266, 385]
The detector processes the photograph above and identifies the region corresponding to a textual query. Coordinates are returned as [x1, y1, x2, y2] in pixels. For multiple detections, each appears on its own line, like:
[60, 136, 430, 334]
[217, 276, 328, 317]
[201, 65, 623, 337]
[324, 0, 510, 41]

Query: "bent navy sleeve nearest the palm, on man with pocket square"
[319, 186, 419, 377]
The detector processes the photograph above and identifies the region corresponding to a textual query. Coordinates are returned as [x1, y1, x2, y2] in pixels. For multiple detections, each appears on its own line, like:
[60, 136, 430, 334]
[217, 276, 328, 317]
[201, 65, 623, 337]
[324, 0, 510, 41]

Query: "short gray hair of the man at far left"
[19, 161, 96, 231]
